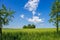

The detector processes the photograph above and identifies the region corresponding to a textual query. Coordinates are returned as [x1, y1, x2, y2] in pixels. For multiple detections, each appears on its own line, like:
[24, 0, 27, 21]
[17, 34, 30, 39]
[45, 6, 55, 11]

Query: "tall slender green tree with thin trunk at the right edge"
[49, 0, 60, 33]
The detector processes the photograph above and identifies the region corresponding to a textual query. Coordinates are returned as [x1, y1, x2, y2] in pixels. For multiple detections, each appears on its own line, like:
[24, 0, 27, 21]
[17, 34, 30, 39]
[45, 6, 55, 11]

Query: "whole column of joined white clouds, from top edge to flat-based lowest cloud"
[24, 0, 43, 23]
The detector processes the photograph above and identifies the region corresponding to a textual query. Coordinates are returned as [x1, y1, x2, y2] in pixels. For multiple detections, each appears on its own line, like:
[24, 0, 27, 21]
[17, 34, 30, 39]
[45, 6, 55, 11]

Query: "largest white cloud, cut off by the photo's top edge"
[24, 0, 39, 11]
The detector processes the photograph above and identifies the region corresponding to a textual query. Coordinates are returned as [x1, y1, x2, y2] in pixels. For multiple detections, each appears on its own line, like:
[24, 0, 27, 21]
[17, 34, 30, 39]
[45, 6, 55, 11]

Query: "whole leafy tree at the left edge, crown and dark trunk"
[0, 4, 14, 40]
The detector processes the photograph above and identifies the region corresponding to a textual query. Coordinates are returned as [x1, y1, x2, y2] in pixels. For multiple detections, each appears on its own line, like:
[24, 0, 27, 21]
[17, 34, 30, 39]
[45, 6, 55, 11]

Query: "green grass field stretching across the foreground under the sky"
[2, 28, 60, 40]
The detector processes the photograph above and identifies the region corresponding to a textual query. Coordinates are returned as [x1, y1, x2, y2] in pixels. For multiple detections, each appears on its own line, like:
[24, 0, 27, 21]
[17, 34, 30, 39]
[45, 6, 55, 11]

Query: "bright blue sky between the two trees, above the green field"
[0, 0, 54, 28]
